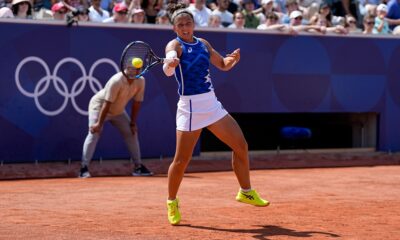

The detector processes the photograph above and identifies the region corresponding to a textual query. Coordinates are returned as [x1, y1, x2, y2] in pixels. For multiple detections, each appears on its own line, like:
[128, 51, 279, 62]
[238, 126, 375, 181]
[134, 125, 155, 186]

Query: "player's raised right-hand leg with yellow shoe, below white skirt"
[208, 114, 269, 206]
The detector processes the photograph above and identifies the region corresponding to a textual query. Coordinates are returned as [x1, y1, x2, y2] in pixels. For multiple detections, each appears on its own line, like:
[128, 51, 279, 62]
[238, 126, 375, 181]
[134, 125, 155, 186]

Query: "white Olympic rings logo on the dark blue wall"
[15, 56, 119, 116]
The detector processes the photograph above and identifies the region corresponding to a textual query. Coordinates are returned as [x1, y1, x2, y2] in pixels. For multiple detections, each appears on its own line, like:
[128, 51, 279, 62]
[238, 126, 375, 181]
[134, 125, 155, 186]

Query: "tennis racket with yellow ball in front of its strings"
[120, 41, 169, 79]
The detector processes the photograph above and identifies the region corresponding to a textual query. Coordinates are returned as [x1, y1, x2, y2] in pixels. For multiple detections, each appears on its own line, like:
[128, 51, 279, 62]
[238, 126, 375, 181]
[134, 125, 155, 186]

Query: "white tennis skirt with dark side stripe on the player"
[176, 91, 228, 131]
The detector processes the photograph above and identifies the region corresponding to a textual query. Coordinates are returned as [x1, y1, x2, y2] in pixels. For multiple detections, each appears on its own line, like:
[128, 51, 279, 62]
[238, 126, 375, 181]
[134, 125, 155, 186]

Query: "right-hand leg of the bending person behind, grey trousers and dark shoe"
[110, 112, 153, 176]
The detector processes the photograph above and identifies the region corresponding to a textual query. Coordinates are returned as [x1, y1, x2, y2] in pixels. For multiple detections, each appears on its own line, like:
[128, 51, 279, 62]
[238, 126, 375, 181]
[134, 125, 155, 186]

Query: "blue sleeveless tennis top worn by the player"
[175, 37, 214, 95]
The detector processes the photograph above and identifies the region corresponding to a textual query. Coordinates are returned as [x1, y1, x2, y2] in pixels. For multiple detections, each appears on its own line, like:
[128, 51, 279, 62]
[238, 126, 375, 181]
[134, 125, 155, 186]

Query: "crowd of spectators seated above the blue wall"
[0, 0, 400, 35]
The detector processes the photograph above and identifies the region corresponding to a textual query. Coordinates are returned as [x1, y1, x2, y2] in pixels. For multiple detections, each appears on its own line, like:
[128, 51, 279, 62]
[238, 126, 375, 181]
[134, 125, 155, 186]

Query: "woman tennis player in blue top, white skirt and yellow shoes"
[163, 4, 269, 225]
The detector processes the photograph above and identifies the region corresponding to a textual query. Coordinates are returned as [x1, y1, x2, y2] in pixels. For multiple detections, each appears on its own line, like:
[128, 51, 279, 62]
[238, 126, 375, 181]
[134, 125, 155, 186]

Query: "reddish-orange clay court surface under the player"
[0, 162, 400, 240]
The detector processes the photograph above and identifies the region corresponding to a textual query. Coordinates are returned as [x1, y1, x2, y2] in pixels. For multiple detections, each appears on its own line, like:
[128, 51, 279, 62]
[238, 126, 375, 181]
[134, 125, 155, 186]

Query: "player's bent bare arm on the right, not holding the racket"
[200, 39, 240, 71]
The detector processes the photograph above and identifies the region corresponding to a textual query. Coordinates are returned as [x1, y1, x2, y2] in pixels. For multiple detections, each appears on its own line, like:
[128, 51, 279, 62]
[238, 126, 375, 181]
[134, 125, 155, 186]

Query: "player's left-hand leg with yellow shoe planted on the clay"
[167, 129, 201, 225]
